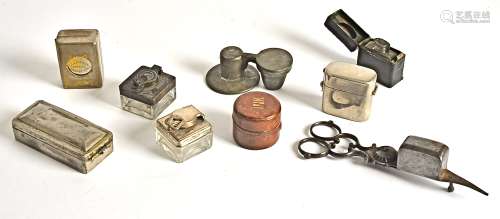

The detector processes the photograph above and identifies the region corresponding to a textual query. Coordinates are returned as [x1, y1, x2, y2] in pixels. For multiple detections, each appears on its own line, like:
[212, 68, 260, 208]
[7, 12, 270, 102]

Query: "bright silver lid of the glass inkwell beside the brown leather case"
[157, 105, 212, 146]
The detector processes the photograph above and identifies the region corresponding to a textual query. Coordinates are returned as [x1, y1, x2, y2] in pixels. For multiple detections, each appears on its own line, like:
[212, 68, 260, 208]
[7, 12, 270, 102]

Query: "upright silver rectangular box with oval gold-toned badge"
[55, 29, 103, 89]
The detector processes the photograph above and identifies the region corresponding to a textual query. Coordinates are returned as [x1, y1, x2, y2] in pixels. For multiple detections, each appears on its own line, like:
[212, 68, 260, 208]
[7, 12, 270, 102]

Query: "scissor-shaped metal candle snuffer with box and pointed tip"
[298, 121, 488, 195]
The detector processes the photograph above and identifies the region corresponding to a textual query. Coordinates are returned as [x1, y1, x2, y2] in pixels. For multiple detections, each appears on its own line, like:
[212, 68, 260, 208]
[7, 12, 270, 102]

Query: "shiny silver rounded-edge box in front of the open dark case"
[322, 62, 377, 122]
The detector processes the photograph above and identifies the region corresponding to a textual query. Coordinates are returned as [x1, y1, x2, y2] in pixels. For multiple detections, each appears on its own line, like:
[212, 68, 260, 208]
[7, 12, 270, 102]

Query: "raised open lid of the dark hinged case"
[325, 9, 370, 52]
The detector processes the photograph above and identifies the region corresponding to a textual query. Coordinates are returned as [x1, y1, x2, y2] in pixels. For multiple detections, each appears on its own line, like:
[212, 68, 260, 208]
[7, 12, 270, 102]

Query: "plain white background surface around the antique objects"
[0, 0, 500, 218]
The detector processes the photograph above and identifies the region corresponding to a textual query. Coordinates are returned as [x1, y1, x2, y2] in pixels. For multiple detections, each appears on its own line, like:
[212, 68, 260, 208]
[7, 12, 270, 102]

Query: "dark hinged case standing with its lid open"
[325, 9, 406, 87]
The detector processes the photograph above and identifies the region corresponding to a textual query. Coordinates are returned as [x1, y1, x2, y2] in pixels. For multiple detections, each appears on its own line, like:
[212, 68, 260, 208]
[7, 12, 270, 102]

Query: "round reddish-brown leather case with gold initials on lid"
[233, 92, 281, 150]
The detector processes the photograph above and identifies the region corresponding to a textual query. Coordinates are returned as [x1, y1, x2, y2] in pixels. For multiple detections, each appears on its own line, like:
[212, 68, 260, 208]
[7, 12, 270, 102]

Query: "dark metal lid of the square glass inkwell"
[119, 65, 175, 105]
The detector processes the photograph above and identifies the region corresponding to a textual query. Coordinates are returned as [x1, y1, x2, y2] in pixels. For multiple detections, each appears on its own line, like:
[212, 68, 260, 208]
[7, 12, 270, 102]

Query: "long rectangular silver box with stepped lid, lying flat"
[12, 100, 113, 173]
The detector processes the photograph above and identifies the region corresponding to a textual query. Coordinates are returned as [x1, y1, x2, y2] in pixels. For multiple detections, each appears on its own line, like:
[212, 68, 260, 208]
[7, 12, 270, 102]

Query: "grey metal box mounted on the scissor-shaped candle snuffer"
[397, 136, 449, 180]
